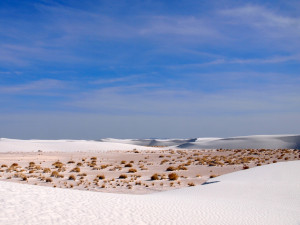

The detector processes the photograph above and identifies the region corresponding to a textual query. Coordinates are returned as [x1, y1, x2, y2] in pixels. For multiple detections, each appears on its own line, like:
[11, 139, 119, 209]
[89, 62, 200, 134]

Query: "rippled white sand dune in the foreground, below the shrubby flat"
[0, 161, 300, 225]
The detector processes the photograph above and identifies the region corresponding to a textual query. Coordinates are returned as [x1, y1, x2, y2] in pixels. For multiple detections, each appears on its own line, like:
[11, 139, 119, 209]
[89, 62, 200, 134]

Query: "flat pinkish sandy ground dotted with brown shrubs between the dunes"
[0, 149, 300, 194]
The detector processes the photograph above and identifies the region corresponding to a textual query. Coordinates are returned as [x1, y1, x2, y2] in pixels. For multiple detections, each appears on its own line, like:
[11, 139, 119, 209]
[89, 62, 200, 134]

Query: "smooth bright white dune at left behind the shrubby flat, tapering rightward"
[0, 138, 156, 152]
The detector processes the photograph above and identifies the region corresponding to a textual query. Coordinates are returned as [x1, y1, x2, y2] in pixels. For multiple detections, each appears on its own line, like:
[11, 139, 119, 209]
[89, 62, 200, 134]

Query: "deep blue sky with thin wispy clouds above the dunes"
[0, 0, 300, 139]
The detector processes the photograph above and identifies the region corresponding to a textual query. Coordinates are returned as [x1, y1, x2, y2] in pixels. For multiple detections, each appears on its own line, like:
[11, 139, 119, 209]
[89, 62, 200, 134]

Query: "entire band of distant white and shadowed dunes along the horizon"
[0, 135, 300, 152]
